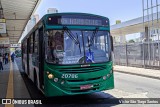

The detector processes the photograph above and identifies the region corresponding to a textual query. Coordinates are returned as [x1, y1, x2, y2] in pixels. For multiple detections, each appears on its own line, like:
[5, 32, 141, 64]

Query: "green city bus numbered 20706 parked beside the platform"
[22, 13, 114, 97]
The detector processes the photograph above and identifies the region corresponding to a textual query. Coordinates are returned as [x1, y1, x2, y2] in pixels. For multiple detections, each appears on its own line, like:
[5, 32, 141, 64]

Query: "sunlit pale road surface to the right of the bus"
[112, 72, 160, 98]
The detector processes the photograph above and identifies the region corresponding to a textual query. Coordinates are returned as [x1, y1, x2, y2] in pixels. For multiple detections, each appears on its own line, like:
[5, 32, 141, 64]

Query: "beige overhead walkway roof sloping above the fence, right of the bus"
[111, 13, 160, 36]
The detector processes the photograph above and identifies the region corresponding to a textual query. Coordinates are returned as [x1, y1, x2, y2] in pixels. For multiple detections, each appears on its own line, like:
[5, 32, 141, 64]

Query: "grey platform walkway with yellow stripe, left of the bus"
[0, 62, 33, 99]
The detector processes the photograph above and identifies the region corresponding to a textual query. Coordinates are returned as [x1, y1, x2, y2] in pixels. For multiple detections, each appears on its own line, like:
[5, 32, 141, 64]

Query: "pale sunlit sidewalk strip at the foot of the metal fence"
[113, 65, 160, 80]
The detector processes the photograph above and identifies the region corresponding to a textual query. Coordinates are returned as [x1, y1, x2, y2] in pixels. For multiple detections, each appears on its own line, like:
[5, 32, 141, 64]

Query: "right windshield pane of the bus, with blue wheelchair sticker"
[84, 31, 109, 63]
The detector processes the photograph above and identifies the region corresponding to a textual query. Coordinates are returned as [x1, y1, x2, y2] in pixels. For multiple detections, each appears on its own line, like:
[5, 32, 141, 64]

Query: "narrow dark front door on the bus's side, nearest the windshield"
[38, 27, 44, 89]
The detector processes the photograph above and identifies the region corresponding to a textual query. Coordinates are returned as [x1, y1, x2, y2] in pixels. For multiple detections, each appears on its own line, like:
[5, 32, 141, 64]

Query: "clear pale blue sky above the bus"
[35, 0, 143, 25]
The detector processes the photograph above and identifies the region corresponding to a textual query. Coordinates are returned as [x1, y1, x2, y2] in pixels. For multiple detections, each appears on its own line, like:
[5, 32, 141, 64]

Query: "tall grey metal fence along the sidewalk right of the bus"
[113, 42, 160, 69]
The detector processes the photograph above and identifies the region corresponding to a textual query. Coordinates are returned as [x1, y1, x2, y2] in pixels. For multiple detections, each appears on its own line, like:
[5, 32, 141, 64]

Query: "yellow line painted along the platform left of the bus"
[5, 62, 14, 107]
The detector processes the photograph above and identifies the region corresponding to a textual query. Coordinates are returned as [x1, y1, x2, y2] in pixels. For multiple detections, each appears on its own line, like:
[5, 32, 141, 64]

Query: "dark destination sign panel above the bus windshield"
[48, 16, 109, 26]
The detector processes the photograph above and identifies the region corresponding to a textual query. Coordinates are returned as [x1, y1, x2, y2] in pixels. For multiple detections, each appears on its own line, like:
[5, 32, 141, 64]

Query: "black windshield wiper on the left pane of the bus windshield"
[63, 26, 81, 54]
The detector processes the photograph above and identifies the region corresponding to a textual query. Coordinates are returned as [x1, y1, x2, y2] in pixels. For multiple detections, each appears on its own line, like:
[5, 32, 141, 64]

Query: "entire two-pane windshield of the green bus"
[45, 29, 109, 64]
